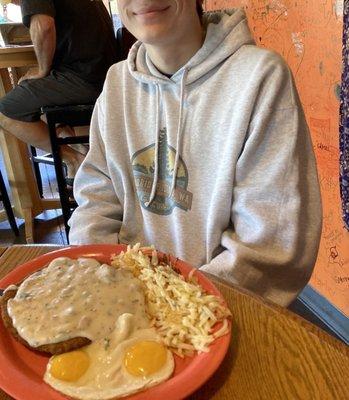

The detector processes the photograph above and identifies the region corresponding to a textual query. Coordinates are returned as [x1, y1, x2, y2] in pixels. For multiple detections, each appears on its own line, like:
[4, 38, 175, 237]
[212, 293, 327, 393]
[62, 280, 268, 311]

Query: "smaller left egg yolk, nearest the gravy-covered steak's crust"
[50, 350, 90, 382]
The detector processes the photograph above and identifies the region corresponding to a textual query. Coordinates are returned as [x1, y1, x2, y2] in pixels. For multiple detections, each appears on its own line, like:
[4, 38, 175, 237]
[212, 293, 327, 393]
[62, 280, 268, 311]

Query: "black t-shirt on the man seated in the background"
[21, 0, 117, 86]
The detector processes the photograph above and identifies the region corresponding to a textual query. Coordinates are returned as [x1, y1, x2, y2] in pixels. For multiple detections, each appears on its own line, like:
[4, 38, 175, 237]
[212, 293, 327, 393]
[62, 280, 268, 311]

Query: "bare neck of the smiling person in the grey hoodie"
[145, 25, 204, 75]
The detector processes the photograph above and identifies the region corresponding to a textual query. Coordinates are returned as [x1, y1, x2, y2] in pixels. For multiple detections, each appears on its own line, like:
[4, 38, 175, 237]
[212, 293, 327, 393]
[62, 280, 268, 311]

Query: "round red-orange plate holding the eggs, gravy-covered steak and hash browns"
[0, 245, 231, 400]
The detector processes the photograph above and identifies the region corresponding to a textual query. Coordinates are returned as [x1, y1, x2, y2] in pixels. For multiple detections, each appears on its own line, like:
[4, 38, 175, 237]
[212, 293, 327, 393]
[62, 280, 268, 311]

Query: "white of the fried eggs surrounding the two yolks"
[44, 314, 175, 400]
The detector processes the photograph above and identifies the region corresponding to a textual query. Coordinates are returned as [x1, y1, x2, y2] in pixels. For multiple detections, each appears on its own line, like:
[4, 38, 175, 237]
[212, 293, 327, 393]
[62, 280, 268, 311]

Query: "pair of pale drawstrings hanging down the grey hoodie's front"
[145, 68, 188, 207]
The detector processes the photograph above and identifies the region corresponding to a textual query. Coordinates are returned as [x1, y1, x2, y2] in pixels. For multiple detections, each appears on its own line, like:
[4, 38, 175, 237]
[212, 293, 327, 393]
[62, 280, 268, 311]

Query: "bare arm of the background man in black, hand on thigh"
[19, 14, 56, 82]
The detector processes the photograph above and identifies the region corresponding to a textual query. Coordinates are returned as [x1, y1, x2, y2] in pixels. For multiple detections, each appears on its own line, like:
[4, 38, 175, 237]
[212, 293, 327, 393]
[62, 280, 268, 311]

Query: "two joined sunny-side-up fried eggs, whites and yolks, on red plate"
[44, 313, 175, 400]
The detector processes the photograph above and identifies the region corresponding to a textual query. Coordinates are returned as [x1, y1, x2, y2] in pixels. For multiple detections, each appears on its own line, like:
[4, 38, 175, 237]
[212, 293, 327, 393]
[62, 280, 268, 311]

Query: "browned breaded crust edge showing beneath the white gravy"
[0, 289, 91, 354]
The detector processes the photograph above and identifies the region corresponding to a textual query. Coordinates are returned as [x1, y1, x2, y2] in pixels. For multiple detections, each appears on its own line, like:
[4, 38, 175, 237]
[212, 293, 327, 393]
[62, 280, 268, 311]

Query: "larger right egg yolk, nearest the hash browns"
[124, 341, 167, 376]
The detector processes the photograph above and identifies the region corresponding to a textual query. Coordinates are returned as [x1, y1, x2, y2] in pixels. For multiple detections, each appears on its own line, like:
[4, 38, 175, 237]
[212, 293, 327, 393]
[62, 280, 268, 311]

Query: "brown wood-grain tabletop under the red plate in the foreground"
[0, 245, 349, 400]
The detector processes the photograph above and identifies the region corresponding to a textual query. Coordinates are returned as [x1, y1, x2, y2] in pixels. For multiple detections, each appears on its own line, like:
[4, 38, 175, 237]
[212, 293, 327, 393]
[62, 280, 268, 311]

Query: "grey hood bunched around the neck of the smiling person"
[127, 9, 254, 85]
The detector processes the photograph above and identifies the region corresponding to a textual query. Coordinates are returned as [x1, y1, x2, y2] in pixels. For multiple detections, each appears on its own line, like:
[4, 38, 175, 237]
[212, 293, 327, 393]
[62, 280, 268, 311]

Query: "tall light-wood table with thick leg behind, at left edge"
[0, 46, 60, 243]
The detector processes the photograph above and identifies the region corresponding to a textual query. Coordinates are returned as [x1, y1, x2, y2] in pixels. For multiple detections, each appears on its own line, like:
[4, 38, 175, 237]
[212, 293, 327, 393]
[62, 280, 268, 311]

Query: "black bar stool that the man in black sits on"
[41, 104, 94, 241]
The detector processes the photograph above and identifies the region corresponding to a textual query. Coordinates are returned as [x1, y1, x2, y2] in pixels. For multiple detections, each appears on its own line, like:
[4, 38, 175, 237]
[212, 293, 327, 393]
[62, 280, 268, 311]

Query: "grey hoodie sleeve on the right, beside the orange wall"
[201, 56, 322, 306]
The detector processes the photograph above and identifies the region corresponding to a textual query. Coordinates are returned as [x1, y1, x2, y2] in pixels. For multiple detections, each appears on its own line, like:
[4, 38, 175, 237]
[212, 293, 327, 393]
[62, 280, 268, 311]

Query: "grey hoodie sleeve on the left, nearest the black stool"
[69, 97, 123, 244]
